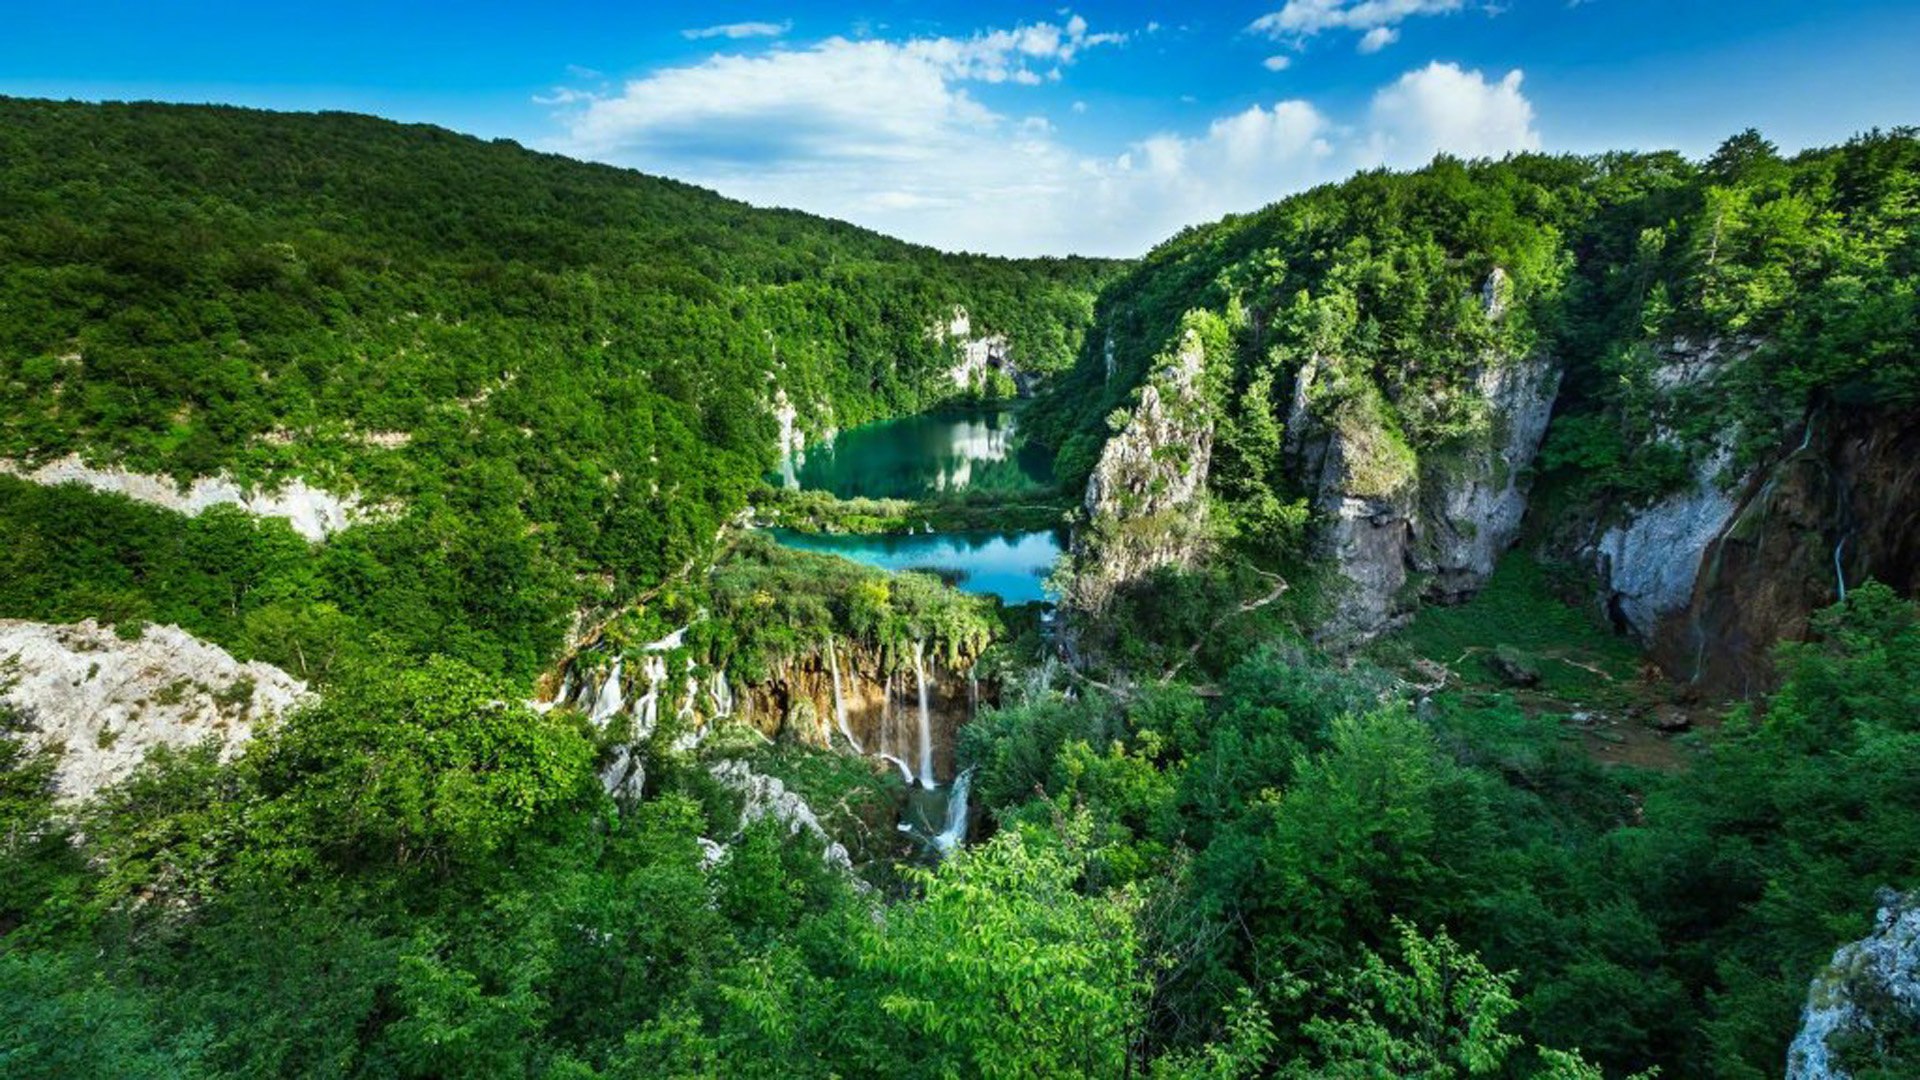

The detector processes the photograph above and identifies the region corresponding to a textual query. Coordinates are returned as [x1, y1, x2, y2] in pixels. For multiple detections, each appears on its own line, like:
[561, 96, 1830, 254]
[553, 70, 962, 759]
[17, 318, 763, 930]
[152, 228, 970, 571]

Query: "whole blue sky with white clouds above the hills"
[0, 0, 1920, 256]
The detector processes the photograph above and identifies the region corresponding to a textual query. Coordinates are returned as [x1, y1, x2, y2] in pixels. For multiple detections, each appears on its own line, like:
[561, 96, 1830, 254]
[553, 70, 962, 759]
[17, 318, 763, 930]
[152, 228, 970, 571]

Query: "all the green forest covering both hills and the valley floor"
[0, 98, 1920, 1080]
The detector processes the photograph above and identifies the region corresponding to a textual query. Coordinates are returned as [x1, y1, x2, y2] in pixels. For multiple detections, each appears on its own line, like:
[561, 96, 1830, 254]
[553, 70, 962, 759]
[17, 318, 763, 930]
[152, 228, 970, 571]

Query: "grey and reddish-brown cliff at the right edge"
[1578, 338, 1920, 696]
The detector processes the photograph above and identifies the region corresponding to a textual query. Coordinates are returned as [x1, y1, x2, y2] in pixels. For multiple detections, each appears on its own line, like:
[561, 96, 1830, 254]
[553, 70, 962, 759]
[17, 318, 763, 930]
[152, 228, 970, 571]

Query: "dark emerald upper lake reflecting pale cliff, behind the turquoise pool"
[780, 407, 1054, 500]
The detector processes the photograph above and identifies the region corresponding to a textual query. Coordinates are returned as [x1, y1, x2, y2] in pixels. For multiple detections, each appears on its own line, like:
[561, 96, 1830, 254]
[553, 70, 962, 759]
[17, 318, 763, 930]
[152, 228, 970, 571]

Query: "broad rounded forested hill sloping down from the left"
[0, 98, 1108, 675]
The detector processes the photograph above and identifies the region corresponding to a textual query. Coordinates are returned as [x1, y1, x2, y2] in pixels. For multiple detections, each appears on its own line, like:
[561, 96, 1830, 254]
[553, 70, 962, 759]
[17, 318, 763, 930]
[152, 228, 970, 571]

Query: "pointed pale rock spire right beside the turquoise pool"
[1062, 317, 1213, 615]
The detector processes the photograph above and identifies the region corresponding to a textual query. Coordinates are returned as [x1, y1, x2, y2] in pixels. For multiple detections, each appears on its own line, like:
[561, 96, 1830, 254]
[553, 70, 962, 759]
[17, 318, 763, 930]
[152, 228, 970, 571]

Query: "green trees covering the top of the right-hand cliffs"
[1025, 129, 1920, 618]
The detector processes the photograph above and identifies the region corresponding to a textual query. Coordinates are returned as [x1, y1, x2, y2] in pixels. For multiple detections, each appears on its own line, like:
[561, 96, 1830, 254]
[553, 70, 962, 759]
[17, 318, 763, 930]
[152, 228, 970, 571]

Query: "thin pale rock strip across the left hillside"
[0, 454, 378, 540]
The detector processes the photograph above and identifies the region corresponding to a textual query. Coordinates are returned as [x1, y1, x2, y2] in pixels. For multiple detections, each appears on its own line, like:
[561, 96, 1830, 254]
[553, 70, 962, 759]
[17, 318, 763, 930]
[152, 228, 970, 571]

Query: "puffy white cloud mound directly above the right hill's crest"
[1367, 61, 1540, 167]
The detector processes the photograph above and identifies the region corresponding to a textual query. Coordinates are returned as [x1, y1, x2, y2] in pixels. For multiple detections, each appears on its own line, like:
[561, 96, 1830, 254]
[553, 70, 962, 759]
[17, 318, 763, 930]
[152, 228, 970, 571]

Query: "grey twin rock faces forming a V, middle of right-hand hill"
[1286, 271, 1559, 646]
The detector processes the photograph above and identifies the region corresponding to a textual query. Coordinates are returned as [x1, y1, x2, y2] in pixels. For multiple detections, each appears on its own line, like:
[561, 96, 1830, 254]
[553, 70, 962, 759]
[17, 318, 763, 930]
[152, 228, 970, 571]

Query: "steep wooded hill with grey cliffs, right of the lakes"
[1027, 129, 1920, 676]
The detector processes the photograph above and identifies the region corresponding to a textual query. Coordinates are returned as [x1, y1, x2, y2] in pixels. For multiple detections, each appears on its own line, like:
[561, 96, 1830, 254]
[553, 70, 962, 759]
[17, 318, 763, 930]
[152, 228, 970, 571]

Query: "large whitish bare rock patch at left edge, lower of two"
[0, 619, 307, 801]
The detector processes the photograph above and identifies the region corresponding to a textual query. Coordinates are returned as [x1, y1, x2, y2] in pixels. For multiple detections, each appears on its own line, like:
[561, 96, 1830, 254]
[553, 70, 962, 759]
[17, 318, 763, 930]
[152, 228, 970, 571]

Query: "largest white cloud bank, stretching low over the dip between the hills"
[547, 17, 1540, 256]
